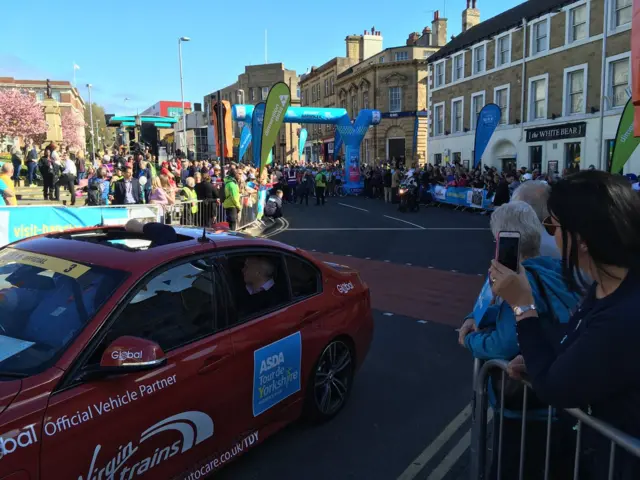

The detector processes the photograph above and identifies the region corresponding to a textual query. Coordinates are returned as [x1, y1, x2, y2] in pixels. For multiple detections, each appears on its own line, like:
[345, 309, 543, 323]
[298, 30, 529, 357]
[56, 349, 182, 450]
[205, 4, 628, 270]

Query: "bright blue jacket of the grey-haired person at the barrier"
[464, 257, 580, 418]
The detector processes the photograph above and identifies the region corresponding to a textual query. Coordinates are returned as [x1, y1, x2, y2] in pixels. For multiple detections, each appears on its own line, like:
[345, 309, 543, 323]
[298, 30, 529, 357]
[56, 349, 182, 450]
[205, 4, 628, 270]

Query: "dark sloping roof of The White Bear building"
[427, 0, 576, 63]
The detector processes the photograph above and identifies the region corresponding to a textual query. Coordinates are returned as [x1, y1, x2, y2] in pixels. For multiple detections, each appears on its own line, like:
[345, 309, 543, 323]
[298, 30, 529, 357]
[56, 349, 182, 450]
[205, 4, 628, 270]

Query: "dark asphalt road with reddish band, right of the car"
[216, 198, 495, 480]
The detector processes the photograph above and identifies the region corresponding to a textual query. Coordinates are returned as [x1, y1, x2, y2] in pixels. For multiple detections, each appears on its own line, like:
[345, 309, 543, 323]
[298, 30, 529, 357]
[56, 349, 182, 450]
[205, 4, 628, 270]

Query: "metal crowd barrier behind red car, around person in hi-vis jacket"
[164, 193, 258, 230]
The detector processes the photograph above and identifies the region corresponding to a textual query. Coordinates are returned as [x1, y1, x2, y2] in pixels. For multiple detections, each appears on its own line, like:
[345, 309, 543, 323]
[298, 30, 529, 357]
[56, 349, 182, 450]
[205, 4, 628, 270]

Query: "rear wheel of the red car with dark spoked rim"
[307, 339, 355, 422]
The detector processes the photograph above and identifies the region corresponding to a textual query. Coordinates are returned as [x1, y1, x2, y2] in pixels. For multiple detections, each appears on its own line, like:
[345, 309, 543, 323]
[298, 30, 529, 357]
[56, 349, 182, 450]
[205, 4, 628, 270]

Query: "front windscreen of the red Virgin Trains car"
[0, 248, 127, 378]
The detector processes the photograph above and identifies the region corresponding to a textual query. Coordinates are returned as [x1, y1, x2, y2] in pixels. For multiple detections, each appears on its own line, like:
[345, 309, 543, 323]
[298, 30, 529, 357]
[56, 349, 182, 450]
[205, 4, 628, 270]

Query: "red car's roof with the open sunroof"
[8, 226, 297, 273]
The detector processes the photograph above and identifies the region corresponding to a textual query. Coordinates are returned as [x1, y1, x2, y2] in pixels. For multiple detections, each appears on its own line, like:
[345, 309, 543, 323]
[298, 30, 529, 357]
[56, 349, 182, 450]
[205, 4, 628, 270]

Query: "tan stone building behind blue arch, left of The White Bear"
[301, 20, 447, 164]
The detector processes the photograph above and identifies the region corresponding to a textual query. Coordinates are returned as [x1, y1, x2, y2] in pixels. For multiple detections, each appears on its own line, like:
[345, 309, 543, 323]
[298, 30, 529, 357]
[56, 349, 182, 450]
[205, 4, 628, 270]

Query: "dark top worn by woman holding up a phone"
[517, 271, 640, 480]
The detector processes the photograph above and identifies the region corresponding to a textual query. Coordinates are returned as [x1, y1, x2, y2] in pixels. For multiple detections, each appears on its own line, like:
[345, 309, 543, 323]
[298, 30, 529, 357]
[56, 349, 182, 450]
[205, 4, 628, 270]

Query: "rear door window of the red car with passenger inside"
[219, 252, 291, 327]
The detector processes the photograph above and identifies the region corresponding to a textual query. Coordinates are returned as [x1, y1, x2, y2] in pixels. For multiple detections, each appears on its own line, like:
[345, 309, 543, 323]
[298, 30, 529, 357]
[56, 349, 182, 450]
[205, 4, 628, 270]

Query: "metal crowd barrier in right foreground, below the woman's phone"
[470, 359, 640, 480]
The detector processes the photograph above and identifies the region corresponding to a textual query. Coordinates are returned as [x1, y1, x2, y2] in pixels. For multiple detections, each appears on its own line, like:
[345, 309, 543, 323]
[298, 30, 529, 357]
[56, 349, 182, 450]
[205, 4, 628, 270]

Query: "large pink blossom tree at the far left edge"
[0, 89, 47, 140]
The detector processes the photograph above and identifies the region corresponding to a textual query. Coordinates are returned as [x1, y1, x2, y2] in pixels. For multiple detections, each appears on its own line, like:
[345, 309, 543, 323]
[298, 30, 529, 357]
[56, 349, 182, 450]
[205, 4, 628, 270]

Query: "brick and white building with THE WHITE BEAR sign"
[428, 0, 640, 172]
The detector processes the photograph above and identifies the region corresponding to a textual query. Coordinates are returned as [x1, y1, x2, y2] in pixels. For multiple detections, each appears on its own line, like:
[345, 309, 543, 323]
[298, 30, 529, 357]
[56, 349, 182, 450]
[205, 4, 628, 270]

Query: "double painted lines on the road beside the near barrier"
[397, 404, 493, 480]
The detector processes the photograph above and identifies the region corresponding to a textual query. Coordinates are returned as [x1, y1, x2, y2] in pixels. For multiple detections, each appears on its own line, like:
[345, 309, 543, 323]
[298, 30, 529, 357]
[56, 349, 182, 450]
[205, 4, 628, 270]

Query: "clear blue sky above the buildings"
[0, 0, 520, 114]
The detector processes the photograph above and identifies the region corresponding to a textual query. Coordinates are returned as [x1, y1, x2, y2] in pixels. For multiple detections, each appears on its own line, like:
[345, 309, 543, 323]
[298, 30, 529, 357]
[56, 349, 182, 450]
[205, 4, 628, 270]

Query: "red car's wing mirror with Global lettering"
[100, 336, 167, 374]
